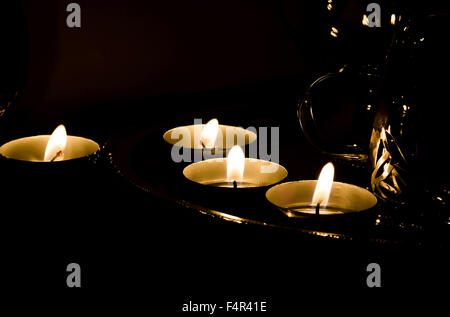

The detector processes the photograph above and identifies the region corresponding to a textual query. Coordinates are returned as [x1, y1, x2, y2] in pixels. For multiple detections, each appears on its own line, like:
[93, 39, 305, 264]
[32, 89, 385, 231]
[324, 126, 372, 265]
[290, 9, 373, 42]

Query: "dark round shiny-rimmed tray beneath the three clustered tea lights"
[106, 118, 449, 247]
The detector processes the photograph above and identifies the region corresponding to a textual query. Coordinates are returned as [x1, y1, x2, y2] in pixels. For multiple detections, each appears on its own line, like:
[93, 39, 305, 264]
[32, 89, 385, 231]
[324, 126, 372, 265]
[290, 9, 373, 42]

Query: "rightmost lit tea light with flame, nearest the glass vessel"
[266, 163, 377, 217]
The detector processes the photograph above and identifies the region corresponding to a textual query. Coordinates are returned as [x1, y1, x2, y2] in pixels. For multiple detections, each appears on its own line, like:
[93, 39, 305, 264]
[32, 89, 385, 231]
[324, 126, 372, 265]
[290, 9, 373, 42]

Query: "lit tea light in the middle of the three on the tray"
[183, 146, 287, 188]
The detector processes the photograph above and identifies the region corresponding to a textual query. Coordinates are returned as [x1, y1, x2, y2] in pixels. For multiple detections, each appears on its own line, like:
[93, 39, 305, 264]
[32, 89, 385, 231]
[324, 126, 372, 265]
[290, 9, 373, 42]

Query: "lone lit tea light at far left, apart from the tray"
[0, 125, 100, 162]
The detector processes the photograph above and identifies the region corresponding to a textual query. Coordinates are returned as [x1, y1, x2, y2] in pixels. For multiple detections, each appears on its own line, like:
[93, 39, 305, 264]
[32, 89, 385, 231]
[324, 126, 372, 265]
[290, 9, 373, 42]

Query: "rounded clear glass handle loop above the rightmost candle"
[297, 69, 374, 163]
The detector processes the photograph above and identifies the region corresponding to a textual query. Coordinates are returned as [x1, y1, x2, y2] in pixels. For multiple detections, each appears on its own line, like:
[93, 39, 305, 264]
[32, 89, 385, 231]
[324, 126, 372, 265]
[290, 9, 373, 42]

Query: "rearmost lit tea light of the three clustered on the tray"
[163, 119, 256, 149]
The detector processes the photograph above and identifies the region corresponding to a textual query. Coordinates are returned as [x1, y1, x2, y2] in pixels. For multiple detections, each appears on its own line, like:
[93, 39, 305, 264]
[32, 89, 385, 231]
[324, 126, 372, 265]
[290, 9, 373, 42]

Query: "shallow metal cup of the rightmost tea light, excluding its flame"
[266, 180, 377, 217]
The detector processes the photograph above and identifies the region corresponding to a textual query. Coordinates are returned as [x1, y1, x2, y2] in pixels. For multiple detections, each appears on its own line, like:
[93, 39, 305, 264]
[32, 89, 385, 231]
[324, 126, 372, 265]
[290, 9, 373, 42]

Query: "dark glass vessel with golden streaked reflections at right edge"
[369, 6, 450, 210]
